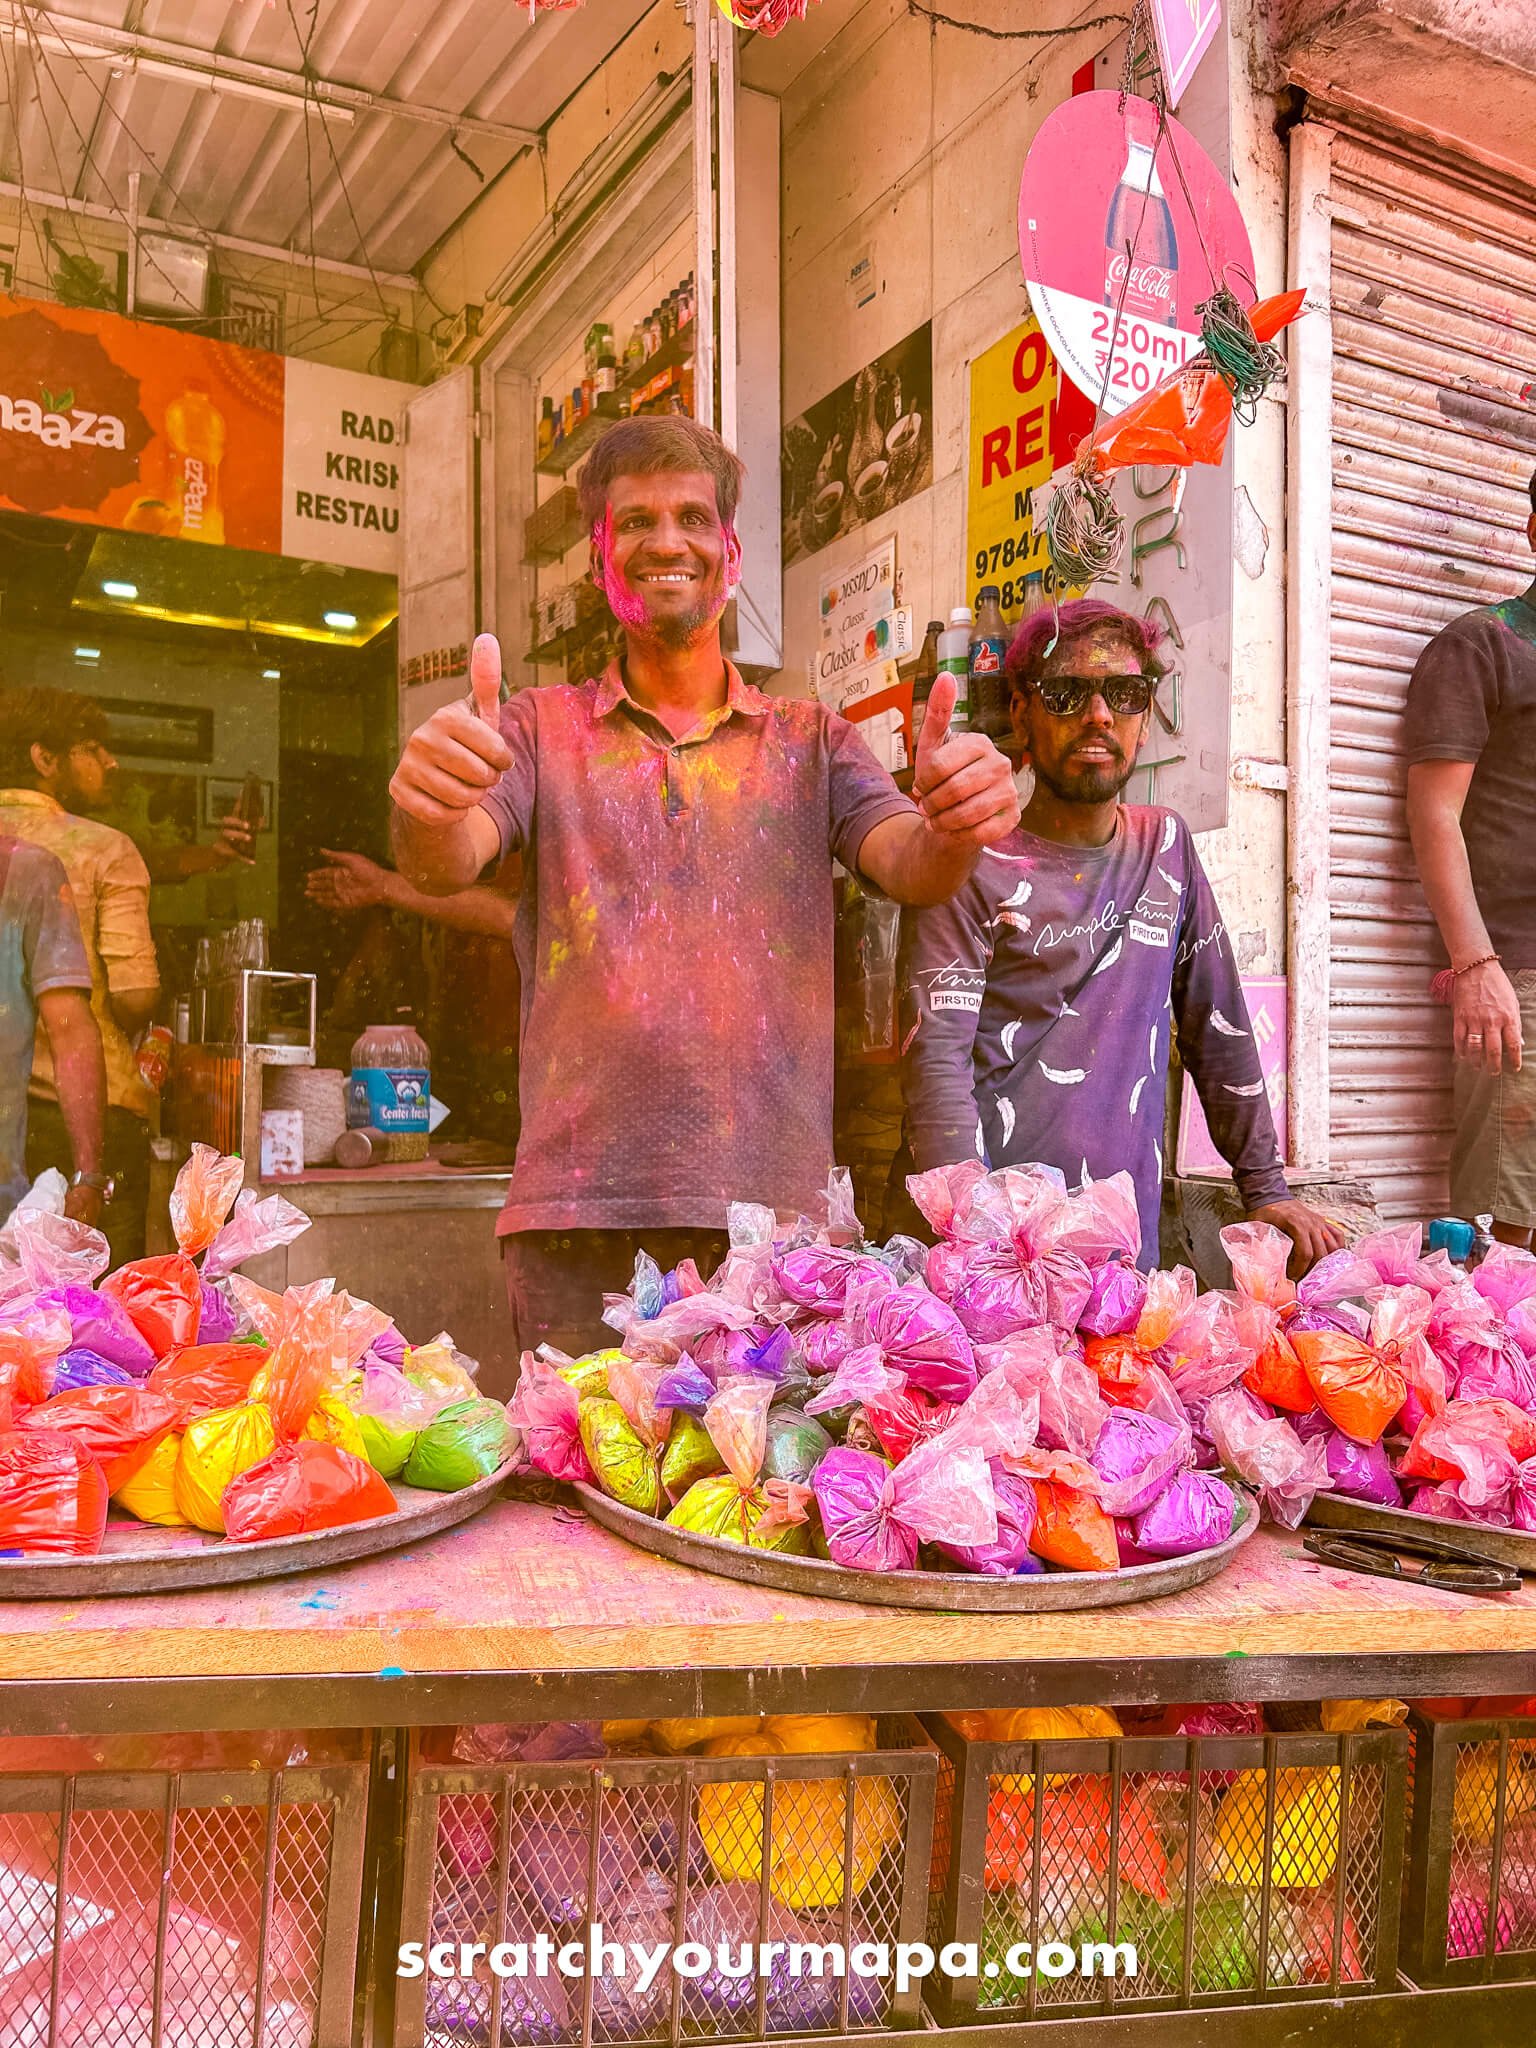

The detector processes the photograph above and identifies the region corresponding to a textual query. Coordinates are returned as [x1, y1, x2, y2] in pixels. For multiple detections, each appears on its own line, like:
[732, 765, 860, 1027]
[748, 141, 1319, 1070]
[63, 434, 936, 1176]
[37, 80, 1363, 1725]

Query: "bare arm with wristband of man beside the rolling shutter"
[1407, 760, 1524, 1073]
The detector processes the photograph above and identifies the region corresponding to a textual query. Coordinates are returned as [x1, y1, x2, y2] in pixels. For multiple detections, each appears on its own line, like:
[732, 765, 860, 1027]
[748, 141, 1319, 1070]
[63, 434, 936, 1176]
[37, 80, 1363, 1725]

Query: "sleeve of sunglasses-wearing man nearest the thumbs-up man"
[901, 879, 993, 1174]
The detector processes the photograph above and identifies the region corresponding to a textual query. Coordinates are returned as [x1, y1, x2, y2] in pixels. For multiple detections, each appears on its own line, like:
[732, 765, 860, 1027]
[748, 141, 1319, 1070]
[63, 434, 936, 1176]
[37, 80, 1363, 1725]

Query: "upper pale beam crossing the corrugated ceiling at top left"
[0, 0, 539, 150]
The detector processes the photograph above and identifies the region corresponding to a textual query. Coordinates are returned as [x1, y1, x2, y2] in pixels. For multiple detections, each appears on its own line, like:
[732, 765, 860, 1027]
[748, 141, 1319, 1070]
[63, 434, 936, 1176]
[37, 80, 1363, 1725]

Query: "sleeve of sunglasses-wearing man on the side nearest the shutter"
[1174, 825, 1290, 1208]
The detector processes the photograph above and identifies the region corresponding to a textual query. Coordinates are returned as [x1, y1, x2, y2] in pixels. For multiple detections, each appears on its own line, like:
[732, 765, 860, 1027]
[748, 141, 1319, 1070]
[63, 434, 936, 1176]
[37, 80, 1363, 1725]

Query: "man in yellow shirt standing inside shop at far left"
[0, 688, 160, 1266]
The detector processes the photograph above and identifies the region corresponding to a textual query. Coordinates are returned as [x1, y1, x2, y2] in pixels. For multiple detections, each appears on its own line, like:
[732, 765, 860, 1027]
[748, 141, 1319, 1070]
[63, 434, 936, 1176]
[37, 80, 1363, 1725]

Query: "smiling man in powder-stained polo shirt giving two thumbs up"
[389, 416, 1018, 1376]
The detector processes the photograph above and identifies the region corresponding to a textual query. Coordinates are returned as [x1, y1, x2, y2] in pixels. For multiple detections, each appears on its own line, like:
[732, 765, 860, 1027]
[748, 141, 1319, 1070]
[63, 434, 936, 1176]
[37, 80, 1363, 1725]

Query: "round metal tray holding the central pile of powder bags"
[571, 1485, 1260, 1614]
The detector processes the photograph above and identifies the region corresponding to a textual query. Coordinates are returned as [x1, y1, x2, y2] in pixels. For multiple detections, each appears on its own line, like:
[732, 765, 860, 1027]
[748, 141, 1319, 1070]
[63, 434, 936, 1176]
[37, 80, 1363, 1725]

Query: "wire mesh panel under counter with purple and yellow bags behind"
[405, 1751, 934, 2048]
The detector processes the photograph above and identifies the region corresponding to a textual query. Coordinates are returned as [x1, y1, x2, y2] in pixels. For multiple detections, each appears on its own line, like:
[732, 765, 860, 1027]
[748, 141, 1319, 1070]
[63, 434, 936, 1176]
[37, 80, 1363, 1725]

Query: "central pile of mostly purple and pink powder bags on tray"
[510, 1165, 1253, 1577]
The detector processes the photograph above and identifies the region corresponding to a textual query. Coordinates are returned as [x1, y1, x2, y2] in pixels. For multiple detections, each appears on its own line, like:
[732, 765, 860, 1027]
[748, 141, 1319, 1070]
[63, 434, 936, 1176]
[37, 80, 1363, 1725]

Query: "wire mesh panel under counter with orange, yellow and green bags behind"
[926, 1720, 1405, 2019]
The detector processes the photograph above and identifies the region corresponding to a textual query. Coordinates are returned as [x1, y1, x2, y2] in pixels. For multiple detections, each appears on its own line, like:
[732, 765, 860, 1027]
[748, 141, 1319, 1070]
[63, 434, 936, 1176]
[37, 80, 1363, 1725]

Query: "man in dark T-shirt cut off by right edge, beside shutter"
[1403, 475, 1536, 1245]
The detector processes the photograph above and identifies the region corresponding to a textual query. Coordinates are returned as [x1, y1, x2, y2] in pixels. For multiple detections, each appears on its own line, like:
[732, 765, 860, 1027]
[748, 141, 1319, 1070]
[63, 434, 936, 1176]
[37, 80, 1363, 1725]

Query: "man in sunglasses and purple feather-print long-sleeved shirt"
[901, 598, 1343, 1270]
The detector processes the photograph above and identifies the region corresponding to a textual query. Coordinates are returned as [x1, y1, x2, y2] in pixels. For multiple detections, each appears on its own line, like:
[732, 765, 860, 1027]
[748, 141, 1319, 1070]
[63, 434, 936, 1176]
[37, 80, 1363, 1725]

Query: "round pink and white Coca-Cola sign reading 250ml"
[1018, 92, 1253, 414]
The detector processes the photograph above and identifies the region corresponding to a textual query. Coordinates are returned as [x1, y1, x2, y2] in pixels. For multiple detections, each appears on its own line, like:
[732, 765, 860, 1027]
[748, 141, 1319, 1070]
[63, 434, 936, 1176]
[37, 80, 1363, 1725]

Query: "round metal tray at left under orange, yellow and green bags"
[0, 1460, 512, 1599]
